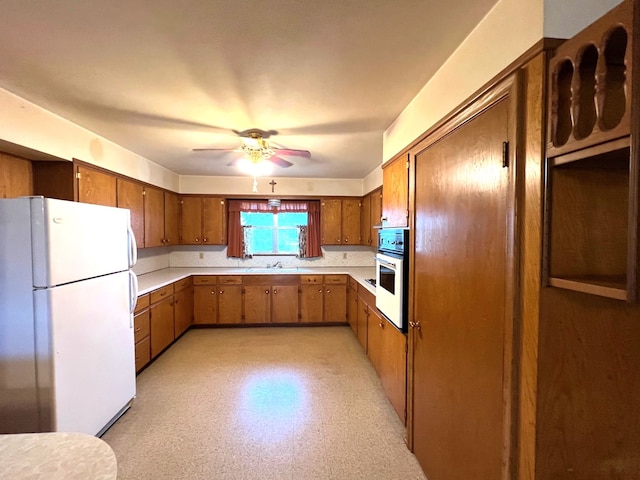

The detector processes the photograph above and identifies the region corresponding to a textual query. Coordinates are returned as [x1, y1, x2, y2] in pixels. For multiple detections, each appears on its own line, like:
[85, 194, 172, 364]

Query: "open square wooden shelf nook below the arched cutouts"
[545, 137, 632, 300]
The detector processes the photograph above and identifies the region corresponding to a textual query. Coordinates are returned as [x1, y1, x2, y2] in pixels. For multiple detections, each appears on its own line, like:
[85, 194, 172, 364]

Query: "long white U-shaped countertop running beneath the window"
[138, 267, 376, 295]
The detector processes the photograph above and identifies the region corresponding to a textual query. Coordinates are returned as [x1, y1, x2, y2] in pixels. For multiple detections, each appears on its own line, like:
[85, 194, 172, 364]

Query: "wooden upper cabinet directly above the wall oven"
[381, 154, 409, 227]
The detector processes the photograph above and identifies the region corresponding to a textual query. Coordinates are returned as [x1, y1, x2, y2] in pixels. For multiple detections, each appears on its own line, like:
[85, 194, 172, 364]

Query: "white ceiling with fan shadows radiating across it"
[0, 0, 496, 178]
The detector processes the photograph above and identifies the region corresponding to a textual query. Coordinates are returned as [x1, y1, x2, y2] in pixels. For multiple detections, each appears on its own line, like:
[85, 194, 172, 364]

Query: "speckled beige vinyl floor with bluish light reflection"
[102, 327, 425, 480]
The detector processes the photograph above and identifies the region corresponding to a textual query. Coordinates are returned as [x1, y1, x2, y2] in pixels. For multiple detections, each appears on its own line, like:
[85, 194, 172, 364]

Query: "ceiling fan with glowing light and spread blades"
[193, 128, 311, 168]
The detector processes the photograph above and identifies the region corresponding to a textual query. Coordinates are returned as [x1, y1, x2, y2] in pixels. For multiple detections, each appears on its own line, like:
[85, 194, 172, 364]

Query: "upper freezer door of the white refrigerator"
[30, 197, 136, 288]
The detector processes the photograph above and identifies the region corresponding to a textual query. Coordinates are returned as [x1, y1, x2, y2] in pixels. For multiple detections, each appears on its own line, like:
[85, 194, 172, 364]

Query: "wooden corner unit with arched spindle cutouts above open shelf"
[544, 1, 640, 301]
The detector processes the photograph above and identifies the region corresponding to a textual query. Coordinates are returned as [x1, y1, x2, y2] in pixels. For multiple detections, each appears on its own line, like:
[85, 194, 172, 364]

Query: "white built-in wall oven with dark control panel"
[376, 228, 409, 332]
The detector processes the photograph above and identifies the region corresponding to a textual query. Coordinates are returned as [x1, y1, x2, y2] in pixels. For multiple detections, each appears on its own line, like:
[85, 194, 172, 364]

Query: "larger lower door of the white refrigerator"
[34, 272, 136, 435]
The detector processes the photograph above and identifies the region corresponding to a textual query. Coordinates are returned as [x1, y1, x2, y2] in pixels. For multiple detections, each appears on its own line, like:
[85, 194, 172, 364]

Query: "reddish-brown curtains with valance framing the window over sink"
[227, 200, 322, 258]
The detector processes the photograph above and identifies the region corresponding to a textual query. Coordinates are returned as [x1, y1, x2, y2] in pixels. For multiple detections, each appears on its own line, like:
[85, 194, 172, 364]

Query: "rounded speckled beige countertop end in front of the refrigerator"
[0, 432, 118, 480]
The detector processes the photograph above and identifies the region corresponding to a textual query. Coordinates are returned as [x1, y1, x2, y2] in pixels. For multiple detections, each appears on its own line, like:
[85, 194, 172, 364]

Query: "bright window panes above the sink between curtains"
[240, 212, 308, 255]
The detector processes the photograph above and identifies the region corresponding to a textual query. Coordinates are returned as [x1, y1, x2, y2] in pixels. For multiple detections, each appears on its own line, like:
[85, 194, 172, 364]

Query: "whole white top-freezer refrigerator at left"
[0, 197, 137, 436]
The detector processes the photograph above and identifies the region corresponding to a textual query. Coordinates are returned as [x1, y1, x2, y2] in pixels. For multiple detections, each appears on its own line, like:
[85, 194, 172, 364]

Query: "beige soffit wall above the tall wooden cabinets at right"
[383, 0, 620, 162]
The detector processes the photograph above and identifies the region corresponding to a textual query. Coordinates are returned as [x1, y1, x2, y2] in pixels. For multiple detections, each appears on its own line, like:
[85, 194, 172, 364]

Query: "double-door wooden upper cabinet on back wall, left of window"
[180, 196, 227, 245]
